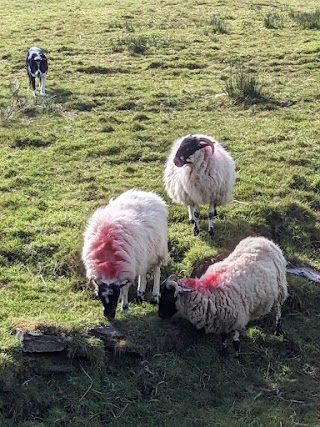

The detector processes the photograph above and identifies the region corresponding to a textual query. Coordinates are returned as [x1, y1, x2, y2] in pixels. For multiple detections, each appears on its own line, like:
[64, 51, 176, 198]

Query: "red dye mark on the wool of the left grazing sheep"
[91, 227, 123, 279]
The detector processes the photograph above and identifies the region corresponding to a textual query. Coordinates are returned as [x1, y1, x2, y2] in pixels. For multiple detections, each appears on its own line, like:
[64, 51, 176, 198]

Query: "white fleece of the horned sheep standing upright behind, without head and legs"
[164, 134, 236, 206]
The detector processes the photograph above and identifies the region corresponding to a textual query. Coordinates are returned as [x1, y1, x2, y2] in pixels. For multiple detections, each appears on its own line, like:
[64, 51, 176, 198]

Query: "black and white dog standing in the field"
[26, 46, 48, 96]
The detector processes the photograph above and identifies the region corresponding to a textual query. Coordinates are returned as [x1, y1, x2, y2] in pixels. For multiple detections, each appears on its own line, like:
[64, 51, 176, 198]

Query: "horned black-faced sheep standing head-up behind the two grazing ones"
[163, 134, 236, 238]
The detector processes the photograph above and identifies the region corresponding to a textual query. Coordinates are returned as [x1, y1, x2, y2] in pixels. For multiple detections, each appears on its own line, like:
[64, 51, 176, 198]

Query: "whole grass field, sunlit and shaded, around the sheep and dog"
[0, 0, 320, 427]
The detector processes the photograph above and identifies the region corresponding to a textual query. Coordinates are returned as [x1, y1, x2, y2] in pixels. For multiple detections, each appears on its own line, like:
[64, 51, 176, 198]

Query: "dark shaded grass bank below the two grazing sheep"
[0, 279, 319, 427]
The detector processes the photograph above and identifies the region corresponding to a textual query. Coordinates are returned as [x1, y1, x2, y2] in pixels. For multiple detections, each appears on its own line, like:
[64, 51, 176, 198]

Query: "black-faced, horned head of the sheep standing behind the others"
[173, 135, 214, 168]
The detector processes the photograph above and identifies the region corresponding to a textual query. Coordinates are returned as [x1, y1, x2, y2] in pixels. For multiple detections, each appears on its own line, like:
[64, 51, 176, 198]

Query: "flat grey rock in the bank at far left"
[16, 329, 68, 353]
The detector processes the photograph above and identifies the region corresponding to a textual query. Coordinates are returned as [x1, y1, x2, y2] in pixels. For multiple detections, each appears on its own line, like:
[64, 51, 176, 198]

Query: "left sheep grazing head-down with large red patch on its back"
[82, 189, 168, 319]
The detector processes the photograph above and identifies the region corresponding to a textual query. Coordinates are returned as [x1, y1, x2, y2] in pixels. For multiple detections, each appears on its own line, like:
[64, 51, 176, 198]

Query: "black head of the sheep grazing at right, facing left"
[158, 276, 191, 319]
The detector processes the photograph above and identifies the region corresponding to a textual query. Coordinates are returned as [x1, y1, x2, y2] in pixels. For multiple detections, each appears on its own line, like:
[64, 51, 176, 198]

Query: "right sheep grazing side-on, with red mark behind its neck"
[158, 237, 288, 357]
